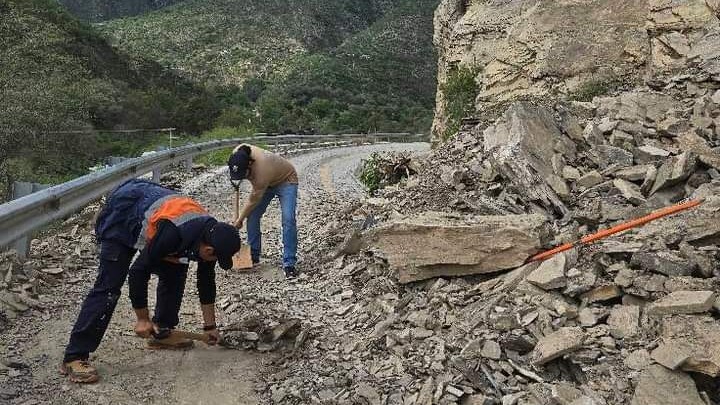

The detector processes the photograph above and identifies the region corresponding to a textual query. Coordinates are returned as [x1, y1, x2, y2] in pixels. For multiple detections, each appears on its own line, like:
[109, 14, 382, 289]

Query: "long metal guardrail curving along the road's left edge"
[0, 133, 428, 251]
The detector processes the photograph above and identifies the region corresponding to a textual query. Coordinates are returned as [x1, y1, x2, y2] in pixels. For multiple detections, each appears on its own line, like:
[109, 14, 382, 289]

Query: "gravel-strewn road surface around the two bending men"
[0, 144, 429, 405]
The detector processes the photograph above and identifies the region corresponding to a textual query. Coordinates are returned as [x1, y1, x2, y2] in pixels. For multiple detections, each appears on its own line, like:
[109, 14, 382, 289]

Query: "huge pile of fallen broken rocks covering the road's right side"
[258, 65, 720, 405]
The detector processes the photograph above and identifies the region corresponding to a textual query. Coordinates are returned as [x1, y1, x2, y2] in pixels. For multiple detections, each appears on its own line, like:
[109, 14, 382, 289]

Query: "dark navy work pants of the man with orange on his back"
[63, 241, 187, 363]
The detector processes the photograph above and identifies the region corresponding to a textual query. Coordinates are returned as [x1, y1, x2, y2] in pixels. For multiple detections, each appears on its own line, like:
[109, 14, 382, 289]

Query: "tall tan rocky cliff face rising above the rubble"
[433, 0, 720, 142]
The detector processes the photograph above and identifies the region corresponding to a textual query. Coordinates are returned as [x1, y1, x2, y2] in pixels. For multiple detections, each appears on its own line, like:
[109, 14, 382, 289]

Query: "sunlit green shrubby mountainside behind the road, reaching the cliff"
[98, 0, 438, 132]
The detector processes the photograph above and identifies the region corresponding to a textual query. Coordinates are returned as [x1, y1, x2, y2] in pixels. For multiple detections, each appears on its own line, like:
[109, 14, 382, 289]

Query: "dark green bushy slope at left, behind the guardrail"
[0, 0, 218, 196]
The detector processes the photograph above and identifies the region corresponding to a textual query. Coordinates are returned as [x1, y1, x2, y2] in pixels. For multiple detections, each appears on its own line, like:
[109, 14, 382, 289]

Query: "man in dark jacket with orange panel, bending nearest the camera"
[61, 180, 241, 383]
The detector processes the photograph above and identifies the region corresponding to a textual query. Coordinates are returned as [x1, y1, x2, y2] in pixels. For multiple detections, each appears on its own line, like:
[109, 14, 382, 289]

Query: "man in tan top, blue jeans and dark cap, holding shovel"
[228, 144, 298, 278]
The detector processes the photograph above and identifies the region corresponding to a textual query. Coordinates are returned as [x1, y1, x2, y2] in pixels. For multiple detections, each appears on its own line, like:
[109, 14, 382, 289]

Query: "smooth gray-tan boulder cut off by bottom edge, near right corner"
[631, 365, 705, 405]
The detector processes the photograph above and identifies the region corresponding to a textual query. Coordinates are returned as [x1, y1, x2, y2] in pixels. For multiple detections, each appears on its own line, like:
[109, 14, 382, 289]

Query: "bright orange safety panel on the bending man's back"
[135, 194, 208, 250]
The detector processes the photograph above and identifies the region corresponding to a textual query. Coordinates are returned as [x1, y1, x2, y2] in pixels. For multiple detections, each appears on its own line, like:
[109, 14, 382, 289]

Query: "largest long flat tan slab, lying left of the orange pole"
[368, 212, 547, 283]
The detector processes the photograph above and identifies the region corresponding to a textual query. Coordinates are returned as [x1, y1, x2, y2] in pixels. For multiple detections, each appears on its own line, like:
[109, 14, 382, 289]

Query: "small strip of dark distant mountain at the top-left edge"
[58, 0, 182, 22]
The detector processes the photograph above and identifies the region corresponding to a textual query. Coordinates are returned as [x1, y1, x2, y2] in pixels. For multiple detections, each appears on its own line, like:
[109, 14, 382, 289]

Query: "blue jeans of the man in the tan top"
[247, 183, 297, 267]
